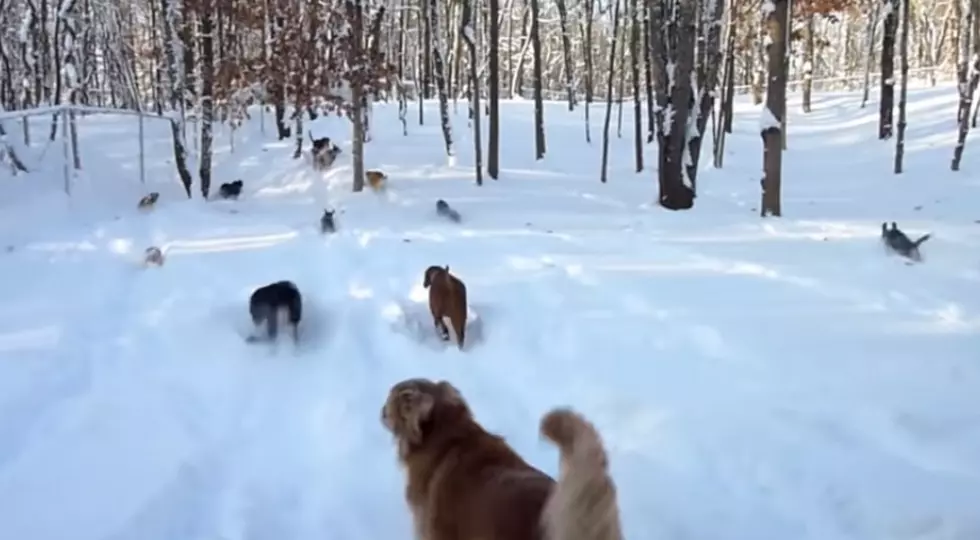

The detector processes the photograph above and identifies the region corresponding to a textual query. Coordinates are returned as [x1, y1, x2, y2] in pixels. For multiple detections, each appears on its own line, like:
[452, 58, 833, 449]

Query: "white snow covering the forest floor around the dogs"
[0, 87, 980, 540]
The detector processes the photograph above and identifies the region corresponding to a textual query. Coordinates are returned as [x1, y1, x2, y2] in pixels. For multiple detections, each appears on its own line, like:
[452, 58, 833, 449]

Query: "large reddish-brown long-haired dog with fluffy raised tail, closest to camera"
[381, 379, 622, 540]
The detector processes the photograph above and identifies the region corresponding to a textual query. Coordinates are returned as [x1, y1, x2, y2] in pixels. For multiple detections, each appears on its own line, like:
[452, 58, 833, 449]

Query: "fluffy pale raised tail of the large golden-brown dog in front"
[541, 408, 623, 540]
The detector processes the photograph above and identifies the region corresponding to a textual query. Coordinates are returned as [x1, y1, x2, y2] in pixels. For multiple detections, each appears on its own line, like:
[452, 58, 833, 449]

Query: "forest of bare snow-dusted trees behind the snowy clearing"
[0, 0, 980, 216]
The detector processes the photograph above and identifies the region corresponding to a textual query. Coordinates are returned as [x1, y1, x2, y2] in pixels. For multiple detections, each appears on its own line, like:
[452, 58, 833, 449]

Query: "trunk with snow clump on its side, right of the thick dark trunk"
[759, 0, 789, 217]
